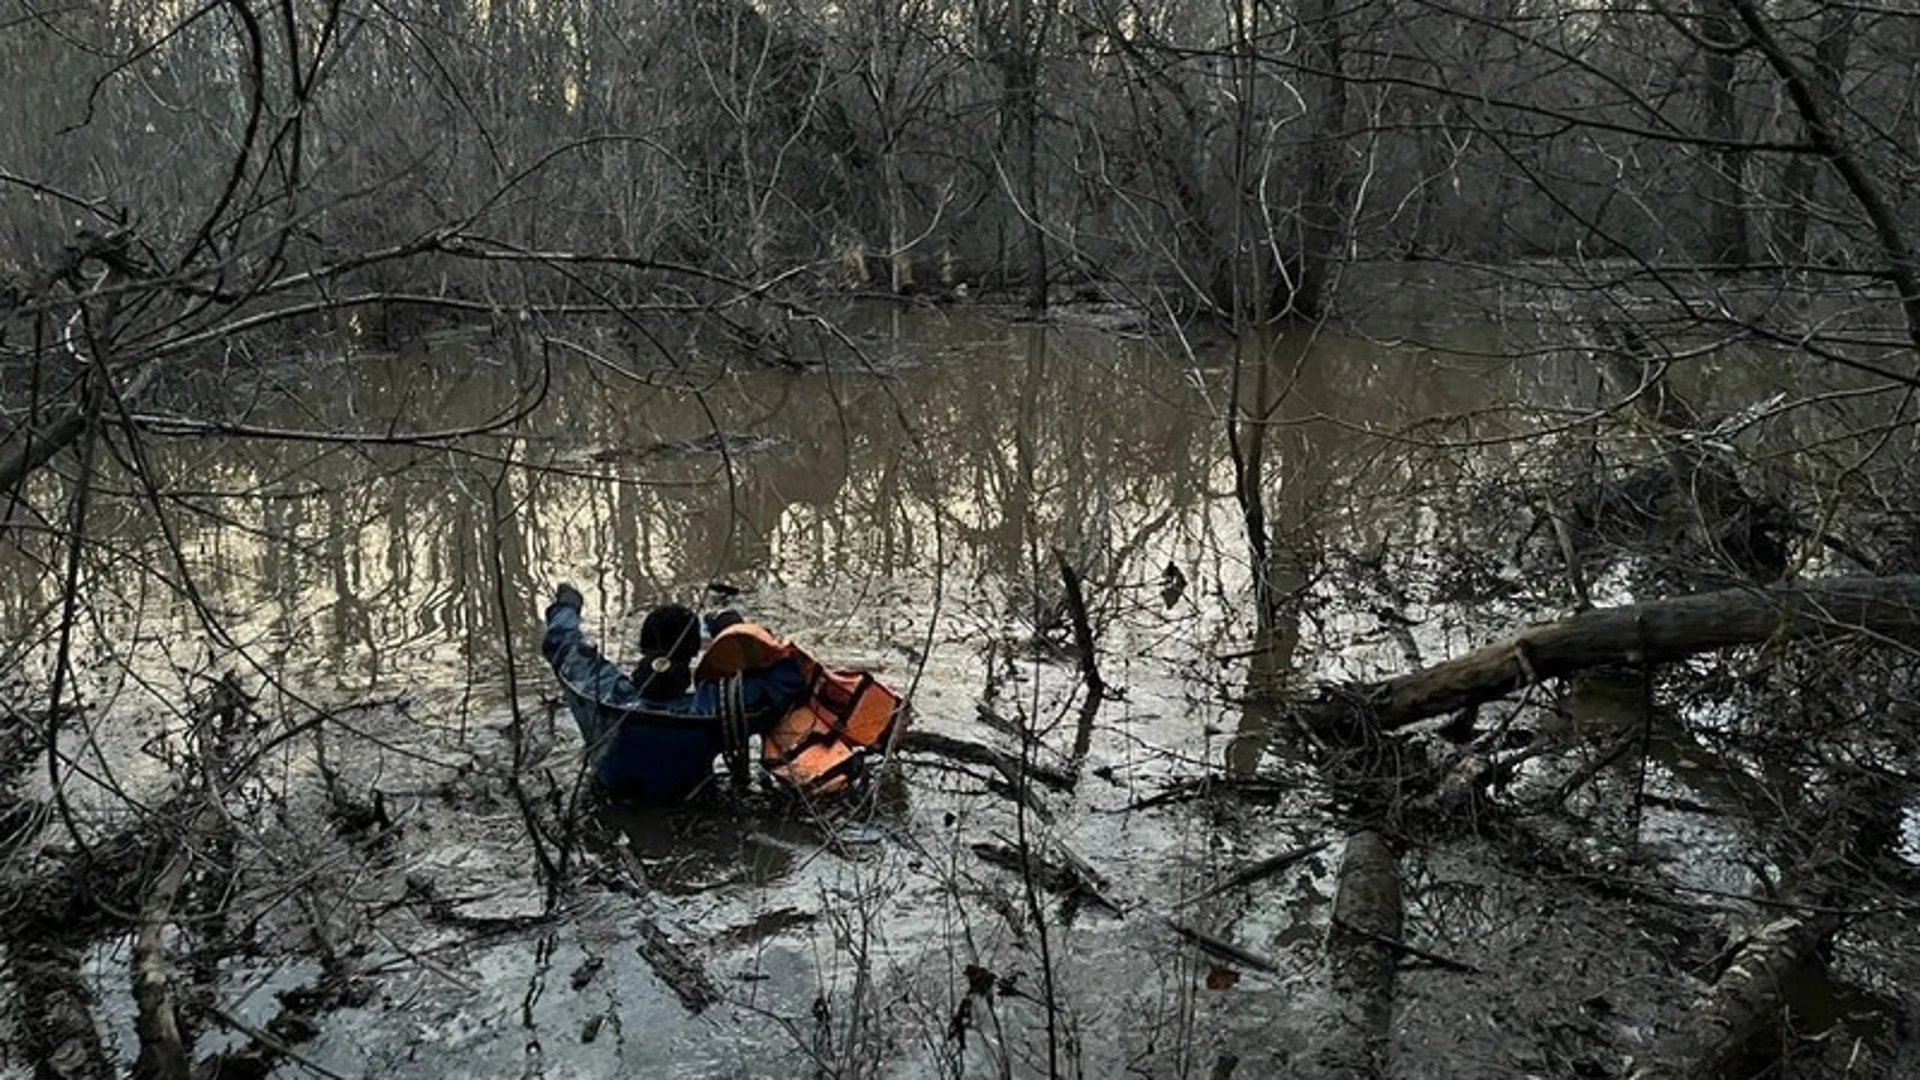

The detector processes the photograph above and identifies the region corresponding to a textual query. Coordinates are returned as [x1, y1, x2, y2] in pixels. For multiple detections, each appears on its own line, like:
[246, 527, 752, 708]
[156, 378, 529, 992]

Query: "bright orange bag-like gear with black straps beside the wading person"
[693, 623, 908, 794]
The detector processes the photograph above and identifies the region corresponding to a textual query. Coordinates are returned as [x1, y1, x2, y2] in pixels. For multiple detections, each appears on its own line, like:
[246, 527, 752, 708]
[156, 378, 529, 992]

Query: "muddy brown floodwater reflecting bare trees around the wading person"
[0, 288, 1914, 1078]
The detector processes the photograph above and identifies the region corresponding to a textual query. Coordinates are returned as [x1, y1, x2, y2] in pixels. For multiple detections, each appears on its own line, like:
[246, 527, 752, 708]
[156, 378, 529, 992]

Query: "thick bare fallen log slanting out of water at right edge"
[1306, 575, 1920, 730]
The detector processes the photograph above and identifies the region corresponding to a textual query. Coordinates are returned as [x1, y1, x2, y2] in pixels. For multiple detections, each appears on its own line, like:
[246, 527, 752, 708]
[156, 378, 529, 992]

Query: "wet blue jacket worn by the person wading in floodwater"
[540, 605, 806, 803]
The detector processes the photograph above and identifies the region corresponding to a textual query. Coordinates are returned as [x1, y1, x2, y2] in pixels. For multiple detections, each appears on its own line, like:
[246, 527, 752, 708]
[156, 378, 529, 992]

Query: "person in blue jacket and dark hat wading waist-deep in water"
[540, 584, 806, 803]
